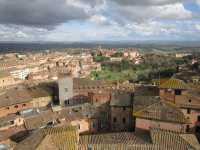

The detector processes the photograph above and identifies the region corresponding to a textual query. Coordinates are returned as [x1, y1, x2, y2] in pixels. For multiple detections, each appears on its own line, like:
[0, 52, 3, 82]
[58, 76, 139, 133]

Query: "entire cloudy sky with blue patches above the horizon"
[0, 0, 200, 42]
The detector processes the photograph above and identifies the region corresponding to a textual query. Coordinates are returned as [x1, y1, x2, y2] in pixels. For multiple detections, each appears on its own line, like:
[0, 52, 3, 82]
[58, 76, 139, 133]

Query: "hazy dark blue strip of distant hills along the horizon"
[0, 41, 200, 53]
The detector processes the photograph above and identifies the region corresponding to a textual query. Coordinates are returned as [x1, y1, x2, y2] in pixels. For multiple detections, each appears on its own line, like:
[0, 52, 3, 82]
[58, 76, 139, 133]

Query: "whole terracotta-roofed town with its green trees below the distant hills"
[0, 47, 200, 150]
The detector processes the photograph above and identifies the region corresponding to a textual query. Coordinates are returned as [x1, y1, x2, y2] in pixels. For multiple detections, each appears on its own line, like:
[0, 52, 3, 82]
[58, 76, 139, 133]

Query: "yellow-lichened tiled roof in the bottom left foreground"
[14, 126, 78, 150]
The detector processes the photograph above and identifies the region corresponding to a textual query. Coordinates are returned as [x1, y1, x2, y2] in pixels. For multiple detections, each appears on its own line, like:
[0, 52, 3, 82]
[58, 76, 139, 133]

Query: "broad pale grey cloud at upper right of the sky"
[104, 0, 193, 25]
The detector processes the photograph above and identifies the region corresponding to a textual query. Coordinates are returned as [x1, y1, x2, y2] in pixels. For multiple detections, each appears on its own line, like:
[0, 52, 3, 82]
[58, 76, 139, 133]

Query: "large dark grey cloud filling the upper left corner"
[0, 0, 90, 27]
